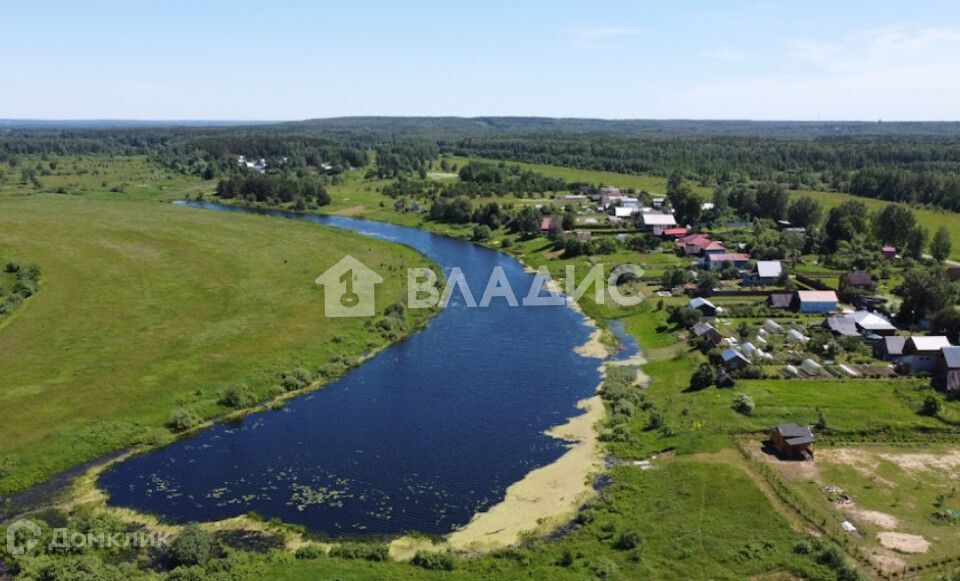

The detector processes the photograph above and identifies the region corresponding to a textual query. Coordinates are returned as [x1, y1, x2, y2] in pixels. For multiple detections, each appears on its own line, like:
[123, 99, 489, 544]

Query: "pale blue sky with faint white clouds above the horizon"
[0, 0, 960, 121]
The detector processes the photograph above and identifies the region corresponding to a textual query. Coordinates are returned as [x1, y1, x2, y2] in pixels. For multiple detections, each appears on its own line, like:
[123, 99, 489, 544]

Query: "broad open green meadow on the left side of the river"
[0, 193, 426, 492]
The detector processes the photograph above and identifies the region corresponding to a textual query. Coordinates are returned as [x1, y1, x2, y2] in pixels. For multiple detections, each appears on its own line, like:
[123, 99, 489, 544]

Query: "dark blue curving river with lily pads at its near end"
[99, 202, 600, 537]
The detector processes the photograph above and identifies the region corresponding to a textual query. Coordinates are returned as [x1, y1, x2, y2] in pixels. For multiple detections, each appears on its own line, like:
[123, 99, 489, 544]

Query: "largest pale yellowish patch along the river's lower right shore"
[448, 396, 605, 553]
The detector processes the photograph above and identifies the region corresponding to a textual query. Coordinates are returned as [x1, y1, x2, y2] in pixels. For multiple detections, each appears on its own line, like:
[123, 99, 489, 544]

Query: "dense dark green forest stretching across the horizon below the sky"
[0, 117, 960, 211]
